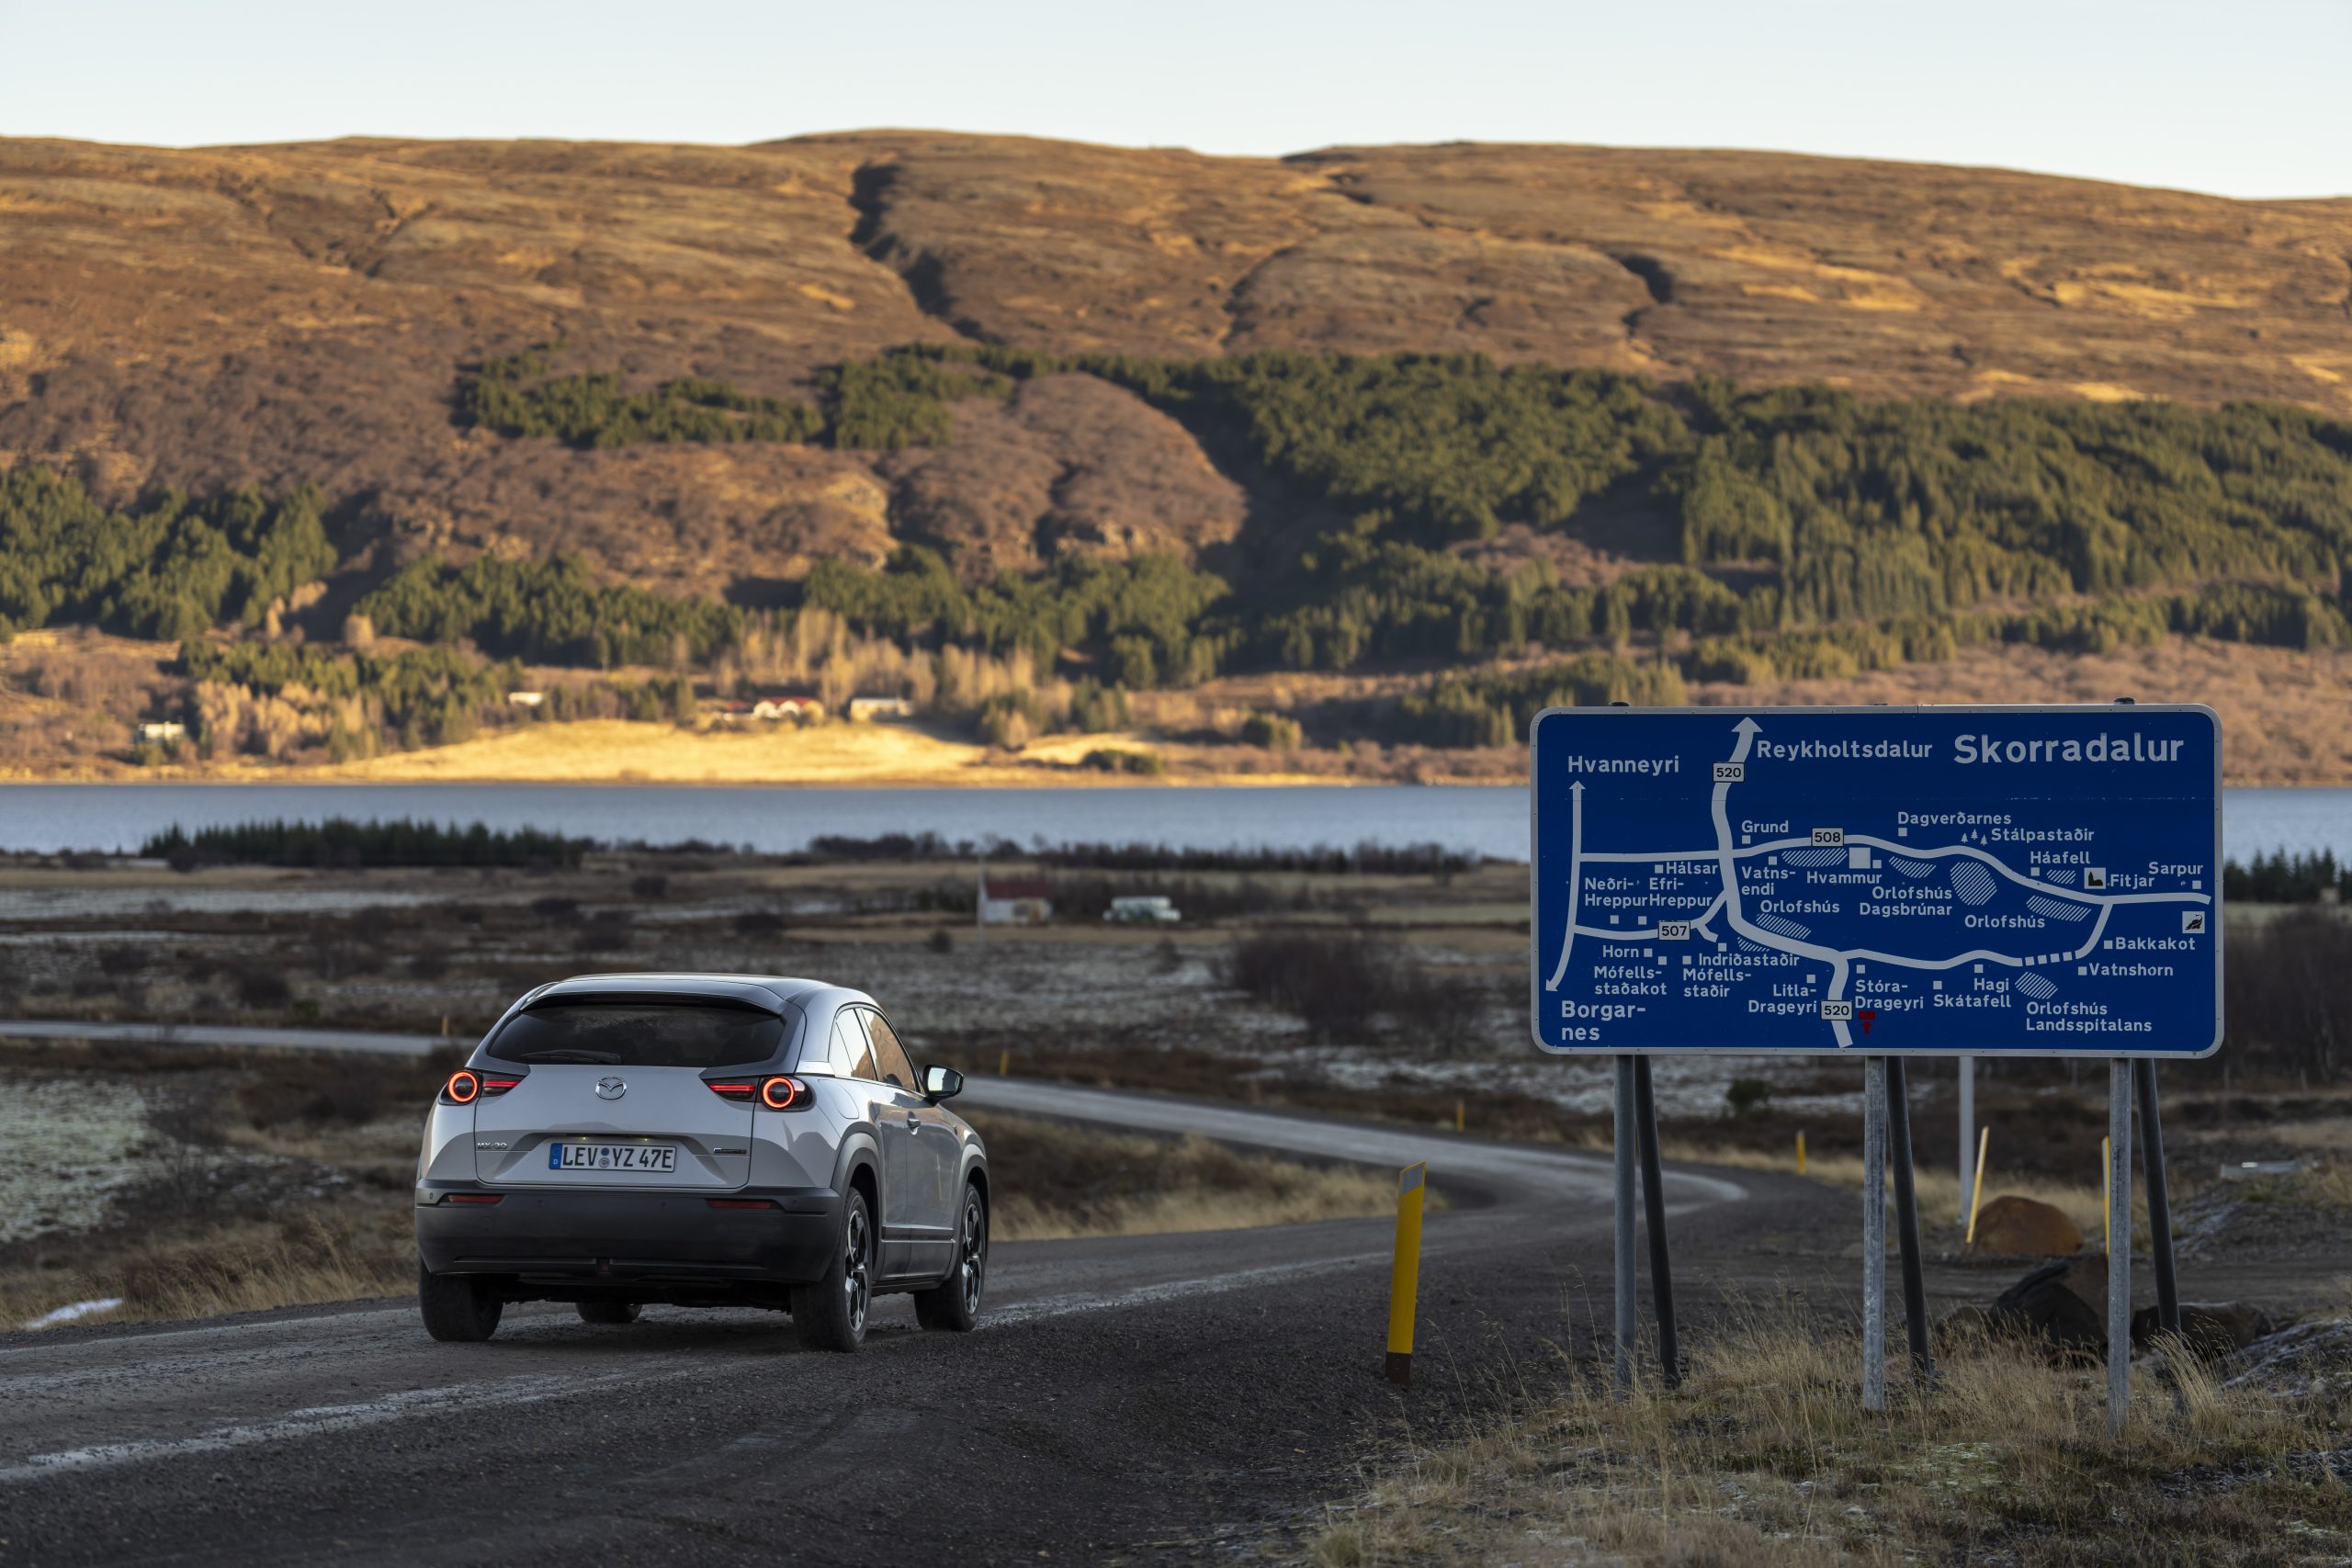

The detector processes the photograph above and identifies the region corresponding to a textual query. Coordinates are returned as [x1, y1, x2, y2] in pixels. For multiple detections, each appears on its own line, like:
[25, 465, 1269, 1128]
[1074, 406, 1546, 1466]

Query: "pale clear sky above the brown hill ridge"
[0, 0, 2352, 195]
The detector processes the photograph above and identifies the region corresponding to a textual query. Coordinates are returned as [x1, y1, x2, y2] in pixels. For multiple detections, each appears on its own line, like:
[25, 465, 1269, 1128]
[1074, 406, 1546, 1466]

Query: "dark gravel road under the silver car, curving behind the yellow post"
[0, 1025, 1746, 1568]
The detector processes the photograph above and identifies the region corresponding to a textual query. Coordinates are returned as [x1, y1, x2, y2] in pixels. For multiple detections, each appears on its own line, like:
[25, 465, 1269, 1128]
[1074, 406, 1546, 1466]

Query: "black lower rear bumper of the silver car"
[416, 1182, 842, 1295]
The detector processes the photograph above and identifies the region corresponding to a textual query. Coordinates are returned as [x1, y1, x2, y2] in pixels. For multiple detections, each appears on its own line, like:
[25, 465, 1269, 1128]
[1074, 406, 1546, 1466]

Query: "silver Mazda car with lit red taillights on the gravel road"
[416, 976, 988, 1349]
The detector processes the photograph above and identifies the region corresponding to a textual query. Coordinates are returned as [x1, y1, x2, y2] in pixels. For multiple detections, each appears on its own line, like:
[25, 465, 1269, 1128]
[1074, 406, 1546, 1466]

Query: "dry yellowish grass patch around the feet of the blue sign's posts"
[1312, 1307, 2352, 1568]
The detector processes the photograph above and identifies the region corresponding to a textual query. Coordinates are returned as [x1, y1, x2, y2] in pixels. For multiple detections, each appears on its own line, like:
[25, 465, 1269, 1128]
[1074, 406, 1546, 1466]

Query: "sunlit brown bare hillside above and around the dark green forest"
[0, 131, 2352, 590]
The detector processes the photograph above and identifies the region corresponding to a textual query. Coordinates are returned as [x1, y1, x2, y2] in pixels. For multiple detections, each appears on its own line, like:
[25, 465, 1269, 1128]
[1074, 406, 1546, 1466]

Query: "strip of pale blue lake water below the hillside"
[0, 783, 2352, 861]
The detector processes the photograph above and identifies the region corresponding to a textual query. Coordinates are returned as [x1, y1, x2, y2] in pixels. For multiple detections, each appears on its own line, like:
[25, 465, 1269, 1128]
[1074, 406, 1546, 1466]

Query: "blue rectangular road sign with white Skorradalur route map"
[1532, 703, 2221, 1055]
